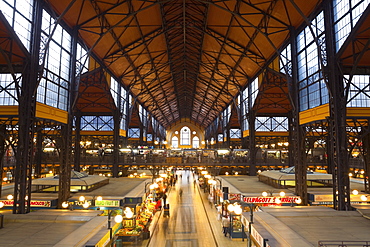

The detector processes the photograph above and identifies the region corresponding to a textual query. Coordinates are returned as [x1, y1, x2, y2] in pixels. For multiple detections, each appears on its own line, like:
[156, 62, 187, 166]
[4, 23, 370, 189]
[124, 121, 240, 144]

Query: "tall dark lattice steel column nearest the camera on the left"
[13, 1, 42, 214]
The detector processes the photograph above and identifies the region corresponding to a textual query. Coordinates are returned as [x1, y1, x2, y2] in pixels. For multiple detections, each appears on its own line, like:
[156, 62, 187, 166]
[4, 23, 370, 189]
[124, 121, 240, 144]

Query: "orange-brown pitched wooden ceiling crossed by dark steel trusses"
[44, 0, 324, 127]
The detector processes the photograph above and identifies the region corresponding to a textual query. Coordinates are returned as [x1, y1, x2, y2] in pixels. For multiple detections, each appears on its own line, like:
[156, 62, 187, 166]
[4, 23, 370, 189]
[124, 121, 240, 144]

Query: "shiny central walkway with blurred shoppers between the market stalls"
[143, 171, 247, 247]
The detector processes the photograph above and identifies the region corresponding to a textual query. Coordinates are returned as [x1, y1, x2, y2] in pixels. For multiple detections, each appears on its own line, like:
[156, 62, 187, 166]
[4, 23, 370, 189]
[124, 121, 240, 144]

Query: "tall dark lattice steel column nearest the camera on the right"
[326, 1, 351, 210]
